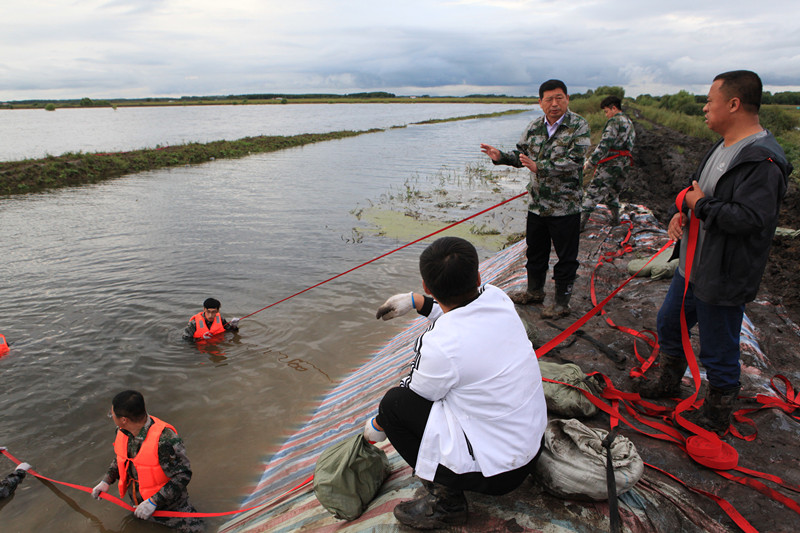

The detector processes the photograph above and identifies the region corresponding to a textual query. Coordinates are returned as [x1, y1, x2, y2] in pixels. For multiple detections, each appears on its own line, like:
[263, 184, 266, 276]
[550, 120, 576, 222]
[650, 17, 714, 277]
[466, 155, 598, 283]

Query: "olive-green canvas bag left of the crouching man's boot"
[314, 432, 389, 520]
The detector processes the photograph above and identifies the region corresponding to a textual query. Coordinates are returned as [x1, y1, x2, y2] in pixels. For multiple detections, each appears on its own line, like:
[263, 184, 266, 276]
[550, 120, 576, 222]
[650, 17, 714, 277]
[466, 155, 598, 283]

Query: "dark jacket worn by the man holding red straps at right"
[672, 132, 792, 305]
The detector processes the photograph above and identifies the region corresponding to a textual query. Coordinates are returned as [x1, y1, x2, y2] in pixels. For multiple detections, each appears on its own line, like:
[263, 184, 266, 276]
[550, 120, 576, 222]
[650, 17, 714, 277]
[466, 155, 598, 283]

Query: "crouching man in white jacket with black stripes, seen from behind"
[365, 237, 547, 529]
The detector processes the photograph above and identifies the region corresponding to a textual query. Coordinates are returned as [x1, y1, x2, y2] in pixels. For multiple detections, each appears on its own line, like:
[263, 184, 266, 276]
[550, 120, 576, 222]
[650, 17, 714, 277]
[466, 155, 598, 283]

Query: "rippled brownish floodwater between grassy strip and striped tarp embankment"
[0, 105, 538, 533]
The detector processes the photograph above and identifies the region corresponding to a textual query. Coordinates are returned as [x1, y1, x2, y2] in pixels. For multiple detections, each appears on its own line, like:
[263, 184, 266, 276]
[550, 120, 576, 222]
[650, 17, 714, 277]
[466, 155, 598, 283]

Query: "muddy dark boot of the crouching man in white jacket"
[394, 480, 467, 529]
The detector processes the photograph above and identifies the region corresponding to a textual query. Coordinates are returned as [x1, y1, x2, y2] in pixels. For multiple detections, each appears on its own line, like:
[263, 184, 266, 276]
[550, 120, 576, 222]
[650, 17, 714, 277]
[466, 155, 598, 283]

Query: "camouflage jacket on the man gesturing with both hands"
[495, 110, 591, 217]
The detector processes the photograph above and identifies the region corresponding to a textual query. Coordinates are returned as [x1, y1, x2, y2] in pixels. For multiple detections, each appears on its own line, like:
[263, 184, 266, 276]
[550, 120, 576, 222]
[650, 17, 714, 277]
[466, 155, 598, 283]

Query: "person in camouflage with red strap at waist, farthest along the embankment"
[581, 96, 636, 231]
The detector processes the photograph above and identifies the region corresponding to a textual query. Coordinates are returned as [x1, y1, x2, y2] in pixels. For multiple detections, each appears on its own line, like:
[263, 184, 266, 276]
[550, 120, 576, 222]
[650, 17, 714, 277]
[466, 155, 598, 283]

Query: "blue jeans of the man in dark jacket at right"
[657, 270, 744, 389]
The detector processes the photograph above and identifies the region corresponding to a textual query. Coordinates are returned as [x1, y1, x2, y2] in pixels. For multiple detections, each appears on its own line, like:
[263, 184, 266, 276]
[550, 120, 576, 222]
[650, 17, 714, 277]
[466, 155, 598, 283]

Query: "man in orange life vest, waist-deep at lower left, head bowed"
[92, 390, 205, 533]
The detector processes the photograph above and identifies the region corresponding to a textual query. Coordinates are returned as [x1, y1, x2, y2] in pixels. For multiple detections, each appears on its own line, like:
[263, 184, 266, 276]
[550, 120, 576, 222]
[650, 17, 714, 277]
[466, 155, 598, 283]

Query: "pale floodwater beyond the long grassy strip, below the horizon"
[0, 104, 533, 161]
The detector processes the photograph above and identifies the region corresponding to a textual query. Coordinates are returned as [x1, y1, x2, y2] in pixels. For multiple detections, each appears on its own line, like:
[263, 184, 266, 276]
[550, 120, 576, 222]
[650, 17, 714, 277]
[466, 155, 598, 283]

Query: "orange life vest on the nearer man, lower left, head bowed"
[114, 416, 178, 500]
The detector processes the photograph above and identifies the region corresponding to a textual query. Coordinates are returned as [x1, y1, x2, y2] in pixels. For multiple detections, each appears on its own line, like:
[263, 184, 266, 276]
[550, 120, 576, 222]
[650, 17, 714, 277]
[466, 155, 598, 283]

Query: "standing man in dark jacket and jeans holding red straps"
[638, 70, 792, 435]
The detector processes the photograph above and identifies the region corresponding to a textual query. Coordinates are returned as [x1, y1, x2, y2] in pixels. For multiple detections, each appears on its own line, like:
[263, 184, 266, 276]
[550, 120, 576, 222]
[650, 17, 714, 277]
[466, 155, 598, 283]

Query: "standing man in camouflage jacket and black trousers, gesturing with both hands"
[481, 80, 591, 318]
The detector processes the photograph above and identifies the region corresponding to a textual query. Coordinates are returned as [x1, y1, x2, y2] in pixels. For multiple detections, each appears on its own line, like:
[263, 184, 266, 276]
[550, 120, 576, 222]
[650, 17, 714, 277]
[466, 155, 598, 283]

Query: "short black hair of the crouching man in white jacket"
[419, 237, 480, 306]
